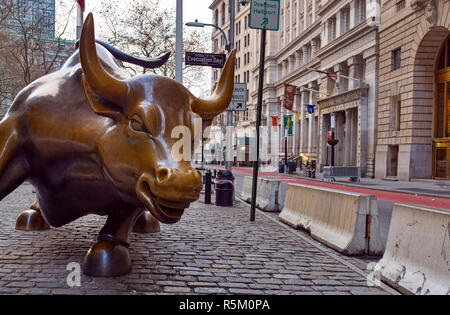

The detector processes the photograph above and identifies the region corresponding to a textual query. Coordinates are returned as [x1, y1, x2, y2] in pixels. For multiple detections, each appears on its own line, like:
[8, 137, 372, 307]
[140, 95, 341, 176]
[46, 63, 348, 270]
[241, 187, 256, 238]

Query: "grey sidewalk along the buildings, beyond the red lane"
[205, 164, 450, 199]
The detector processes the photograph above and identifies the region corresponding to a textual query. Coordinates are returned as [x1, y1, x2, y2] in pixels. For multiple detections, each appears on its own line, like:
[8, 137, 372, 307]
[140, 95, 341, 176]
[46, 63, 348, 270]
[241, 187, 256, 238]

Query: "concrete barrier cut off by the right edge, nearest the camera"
[374, 204, 450, 295]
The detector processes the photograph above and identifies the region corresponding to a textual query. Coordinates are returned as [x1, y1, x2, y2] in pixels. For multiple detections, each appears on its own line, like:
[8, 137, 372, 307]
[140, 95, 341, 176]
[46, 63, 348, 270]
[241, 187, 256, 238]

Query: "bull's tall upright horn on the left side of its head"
[80, 13, 129, 106]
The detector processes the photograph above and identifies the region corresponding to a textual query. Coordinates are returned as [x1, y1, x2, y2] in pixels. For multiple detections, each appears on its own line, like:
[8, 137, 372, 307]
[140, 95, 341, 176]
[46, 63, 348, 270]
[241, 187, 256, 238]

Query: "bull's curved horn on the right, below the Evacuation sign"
[191, 49, 236, 119]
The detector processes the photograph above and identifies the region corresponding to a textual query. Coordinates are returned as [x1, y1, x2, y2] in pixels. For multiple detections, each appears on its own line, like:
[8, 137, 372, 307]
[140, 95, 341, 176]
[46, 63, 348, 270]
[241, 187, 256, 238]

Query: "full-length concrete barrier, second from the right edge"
[279, 184, 384, 255]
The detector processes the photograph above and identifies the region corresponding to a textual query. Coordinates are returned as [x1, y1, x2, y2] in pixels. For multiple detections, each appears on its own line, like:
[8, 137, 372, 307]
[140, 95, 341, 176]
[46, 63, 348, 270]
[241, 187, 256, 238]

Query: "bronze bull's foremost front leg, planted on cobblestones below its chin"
[83, 209, 143, 277]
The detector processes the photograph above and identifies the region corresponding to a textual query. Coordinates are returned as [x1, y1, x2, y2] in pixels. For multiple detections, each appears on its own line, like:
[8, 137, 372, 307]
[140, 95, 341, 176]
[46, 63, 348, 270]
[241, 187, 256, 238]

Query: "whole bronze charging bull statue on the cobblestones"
[0, 14, 235, 276]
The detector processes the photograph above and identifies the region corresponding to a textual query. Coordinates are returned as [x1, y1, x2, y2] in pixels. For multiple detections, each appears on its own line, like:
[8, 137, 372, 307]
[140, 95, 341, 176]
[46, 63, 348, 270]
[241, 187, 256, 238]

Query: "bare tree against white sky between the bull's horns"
[100, 0, 209, 93]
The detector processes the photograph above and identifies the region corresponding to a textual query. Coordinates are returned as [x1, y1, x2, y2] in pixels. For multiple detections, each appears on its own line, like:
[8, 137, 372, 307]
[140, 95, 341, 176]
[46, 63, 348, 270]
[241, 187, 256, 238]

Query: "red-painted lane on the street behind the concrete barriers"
[208, 166, 450, 210]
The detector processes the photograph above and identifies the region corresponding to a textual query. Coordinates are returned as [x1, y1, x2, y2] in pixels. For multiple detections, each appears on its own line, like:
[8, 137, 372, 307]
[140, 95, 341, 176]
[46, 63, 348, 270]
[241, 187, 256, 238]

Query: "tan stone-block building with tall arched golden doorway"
[375, 0, 450, 180]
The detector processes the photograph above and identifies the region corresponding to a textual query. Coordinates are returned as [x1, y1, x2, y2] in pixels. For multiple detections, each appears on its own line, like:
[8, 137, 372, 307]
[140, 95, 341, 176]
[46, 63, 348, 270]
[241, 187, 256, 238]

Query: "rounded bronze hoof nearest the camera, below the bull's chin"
[83, 241, 131, 277]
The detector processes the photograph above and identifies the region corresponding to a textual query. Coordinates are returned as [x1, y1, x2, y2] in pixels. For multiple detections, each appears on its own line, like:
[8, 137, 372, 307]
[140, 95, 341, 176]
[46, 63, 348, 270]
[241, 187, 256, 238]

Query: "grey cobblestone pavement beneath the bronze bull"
[0, 184, 392, 294]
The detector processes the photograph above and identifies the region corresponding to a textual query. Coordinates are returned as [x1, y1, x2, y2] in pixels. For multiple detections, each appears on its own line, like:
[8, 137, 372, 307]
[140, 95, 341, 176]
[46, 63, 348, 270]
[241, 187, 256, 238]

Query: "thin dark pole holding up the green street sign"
[250, 29, 266, 222]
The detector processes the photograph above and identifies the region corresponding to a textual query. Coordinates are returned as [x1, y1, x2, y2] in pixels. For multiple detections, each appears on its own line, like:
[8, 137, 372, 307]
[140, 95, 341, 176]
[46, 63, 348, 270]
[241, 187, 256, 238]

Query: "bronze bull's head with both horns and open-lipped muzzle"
[80, 14, 235, 223]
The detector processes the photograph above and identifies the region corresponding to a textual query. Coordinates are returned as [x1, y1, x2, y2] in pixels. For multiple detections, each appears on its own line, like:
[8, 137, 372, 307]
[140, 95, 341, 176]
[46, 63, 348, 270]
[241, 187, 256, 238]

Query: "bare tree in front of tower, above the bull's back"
[0, 0, 74, 103]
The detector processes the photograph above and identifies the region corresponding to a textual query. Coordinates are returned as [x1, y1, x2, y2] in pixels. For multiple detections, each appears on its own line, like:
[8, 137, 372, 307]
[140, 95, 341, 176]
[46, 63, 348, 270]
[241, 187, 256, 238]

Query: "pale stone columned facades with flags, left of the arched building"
[210, 0, 379, 176]
